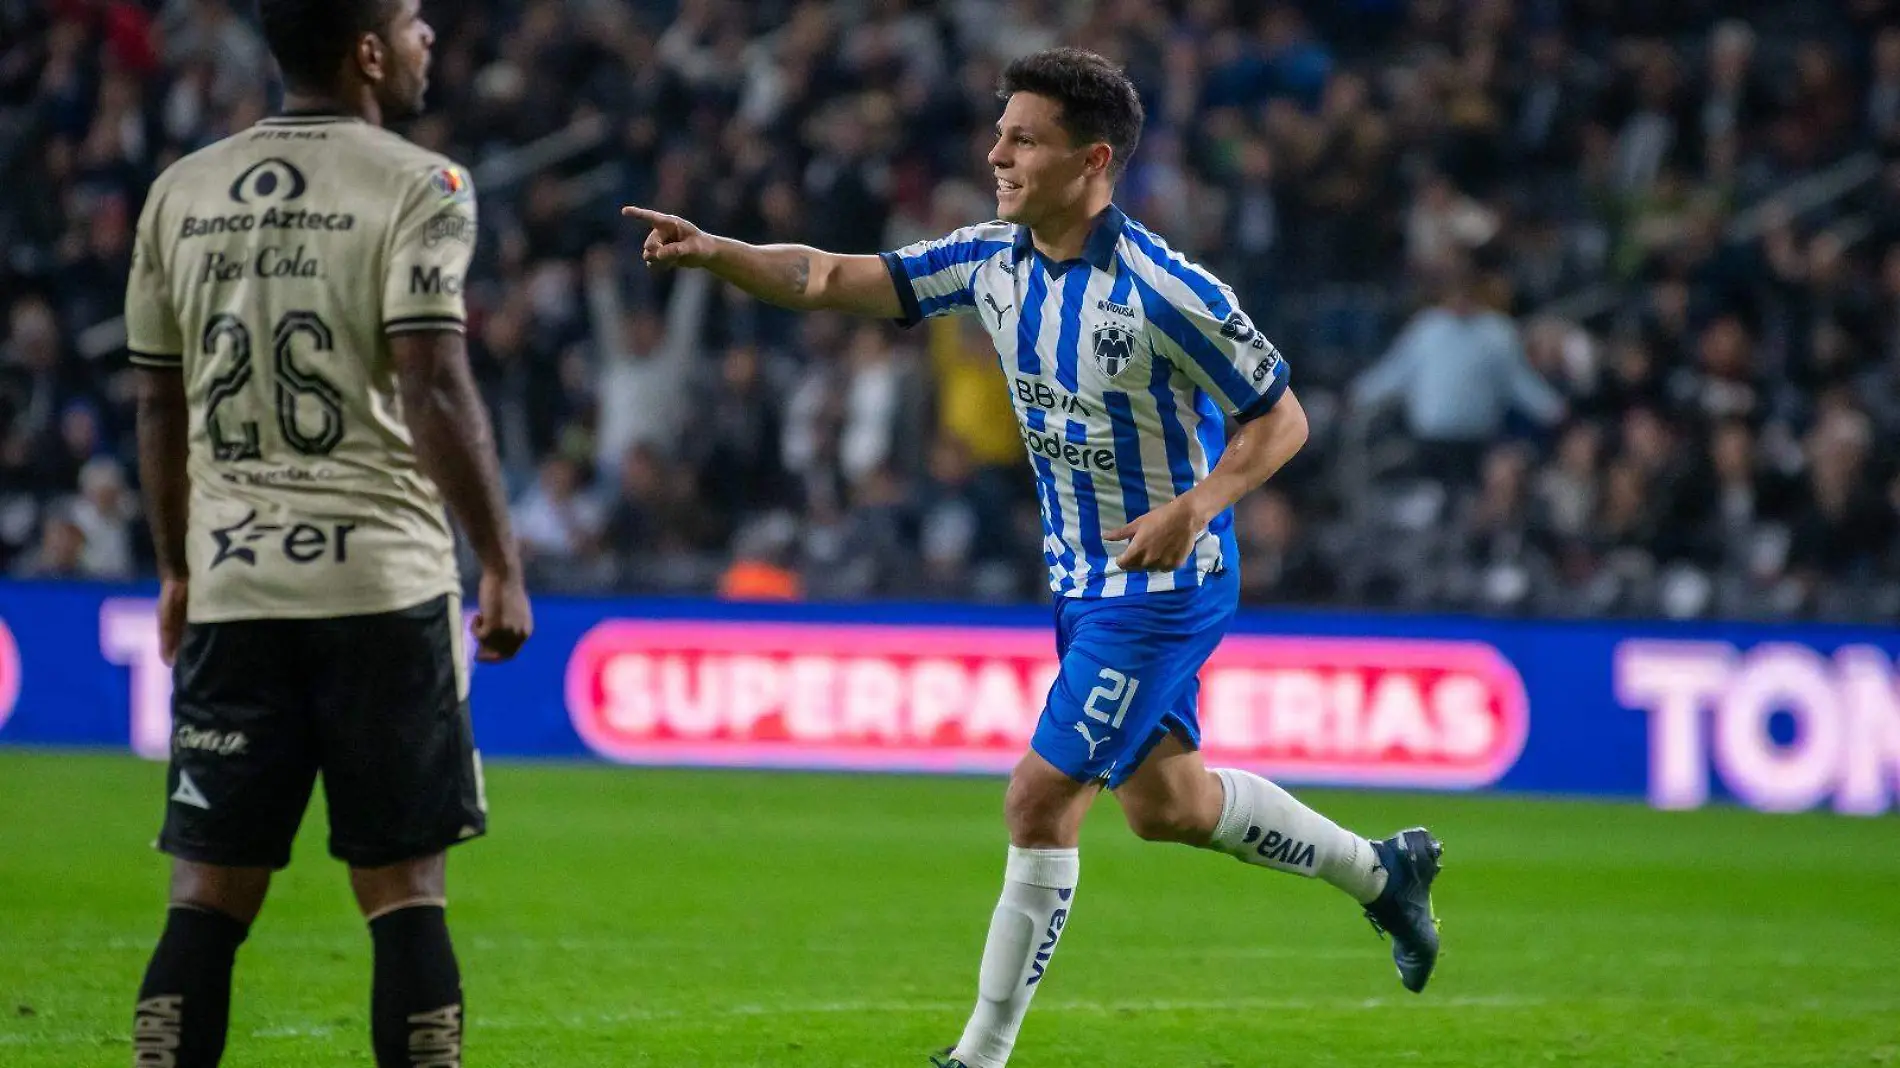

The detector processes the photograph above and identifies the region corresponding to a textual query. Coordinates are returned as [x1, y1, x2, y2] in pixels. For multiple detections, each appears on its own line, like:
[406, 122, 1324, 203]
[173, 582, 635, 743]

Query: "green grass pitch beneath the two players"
[0, 753, 1900, 1068]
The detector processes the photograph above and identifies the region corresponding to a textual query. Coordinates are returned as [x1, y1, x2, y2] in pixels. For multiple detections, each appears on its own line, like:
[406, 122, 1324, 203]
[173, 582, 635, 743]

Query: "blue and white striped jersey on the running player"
[884, 205, 1290, 597]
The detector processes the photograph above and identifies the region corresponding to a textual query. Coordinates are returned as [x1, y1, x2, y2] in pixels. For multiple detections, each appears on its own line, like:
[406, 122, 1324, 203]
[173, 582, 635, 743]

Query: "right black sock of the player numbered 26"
[369, 905, 462, 1068]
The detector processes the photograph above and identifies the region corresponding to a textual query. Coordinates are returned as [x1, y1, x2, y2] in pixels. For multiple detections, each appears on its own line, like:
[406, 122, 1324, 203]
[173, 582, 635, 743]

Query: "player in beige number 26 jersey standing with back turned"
[125, 0, 532, 1068]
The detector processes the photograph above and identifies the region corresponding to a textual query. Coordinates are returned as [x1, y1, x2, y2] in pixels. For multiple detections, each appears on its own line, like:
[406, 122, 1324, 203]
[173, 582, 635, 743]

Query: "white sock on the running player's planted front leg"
[956, 846, 1081, 1068]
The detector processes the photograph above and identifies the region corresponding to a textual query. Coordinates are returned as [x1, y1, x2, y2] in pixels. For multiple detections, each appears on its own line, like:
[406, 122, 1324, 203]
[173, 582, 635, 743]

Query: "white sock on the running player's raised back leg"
[1208, 768, 1385, 905]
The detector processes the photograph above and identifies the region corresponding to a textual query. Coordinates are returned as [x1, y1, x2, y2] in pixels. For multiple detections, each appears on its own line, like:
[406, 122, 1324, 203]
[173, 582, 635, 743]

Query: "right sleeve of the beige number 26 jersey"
[382, 163, 475, 334]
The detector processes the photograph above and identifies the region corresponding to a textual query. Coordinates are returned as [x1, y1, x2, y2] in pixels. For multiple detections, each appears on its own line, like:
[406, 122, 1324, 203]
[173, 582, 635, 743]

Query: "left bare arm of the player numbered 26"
[139, 367, 192, 663]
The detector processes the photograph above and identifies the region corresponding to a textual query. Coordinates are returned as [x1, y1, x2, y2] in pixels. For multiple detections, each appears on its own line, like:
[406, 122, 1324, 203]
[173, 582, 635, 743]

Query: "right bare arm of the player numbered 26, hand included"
[390, 331, 534, 661]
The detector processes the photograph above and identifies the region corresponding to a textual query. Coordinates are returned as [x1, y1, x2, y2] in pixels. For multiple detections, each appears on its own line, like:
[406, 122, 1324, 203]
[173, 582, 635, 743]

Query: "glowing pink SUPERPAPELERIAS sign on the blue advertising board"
[566, 621, 1528, 789]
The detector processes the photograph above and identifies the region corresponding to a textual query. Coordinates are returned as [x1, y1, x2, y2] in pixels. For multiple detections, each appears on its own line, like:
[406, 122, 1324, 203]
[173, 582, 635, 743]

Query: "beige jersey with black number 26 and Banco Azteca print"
[125, 118, 475, 623]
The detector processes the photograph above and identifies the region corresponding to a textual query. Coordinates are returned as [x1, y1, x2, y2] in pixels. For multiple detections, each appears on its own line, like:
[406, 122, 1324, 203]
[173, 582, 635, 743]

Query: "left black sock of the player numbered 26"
[131, 905, 251, 1068]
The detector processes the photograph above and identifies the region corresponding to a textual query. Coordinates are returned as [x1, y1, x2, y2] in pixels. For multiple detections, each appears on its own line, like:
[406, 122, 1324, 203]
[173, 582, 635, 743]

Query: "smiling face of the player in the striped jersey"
[990, 93, 1113, 226]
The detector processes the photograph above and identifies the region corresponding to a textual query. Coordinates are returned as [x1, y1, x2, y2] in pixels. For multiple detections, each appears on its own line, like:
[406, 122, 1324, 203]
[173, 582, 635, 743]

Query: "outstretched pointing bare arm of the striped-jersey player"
[619, 207, 904, 311]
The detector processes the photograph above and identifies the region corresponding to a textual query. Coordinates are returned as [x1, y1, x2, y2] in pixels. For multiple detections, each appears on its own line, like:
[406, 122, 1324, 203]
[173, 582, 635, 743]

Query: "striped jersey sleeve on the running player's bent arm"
[1136, 257, 1292, 422]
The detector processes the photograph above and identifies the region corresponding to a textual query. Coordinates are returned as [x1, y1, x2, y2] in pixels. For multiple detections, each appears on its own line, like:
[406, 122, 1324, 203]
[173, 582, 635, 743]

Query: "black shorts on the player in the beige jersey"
[158, 597, 488, 868]
